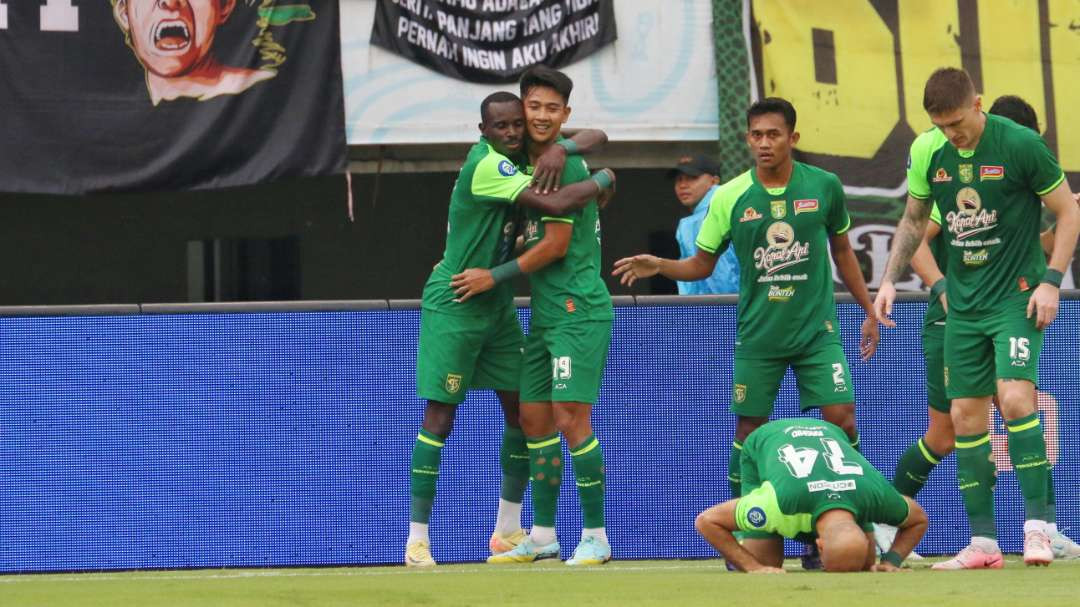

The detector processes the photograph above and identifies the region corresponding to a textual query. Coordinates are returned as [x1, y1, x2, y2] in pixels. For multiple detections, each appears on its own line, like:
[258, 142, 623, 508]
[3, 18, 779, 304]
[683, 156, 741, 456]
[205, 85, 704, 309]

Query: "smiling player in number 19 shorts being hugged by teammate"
[456, 66, 613, 566]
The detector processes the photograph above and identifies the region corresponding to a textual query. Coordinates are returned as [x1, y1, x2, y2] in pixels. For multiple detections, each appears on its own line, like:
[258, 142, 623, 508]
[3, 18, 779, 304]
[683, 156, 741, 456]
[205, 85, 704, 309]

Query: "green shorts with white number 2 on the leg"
[731, 336, 855, 417]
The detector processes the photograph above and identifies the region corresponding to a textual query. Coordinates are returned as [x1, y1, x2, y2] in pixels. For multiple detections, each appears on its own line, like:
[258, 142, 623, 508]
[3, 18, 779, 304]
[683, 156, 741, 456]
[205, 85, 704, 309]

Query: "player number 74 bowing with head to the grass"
[694, 418, 928, 574]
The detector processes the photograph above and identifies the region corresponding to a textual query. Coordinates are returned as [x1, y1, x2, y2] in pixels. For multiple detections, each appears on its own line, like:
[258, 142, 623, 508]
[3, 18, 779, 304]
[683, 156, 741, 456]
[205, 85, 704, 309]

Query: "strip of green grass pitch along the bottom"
[0, 555, 1080, 607]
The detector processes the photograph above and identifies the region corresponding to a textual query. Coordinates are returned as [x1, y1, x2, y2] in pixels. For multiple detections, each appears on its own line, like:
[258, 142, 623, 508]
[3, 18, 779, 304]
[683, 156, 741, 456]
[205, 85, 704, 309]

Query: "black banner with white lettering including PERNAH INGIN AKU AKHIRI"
[372, 0, 616, 83]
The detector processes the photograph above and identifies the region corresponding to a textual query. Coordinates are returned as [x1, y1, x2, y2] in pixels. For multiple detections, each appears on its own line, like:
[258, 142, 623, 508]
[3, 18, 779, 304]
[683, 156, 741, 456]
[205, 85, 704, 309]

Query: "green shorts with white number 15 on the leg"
[945, 302, 1042, 399]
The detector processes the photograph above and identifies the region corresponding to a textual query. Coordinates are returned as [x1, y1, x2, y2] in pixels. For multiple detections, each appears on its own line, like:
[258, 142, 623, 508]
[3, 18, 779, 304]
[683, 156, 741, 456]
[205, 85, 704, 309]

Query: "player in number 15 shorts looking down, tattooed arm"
[875, 68, 1080, 569]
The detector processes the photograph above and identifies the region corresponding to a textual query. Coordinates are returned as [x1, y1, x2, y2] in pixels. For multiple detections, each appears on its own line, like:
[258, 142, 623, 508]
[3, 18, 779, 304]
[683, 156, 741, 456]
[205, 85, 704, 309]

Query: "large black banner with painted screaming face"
[0, 0, 346, 193]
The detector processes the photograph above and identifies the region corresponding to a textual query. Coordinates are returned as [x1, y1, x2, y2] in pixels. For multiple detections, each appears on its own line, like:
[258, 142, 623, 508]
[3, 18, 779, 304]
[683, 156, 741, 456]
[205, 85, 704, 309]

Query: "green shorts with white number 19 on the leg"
[521, 321, 611, 404]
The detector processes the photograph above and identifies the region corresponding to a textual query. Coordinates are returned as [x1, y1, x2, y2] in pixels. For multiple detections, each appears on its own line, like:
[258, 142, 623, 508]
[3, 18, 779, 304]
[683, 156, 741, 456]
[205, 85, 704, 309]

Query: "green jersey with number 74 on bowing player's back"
[735, 418, 908, 538]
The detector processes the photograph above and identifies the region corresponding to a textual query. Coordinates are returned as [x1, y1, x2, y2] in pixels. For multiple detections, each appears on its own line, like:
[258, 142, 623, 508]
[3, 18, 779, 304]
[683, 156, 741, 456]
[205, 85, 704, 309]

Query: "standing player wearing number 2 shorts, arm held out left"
[613, 97, 878, 565]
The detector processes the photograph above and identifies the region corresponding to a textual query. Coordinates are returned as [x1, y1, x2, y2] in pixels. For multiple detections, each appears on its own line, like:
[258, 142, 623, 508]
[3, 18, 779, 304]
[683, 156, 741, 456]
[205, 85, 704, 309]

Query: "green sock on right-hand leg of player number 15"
[1005, 413, 1053, 522]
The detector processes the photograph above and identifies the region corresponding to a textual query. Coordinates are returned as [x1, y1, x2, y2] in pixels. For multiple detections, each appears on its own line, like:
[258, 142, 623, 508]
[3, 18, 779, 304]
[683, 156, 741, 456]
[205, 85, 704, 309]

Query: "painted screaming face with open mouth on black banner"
[112, 0, 276, 105]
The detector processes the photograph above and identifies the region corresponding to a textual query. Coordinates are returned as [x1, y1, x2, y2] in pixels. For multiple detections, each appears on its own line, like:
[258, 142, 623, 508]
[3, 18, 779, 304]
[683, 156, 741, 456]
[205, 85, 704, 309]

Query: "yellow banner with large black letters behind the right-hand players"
[744, 0, 1080, 288]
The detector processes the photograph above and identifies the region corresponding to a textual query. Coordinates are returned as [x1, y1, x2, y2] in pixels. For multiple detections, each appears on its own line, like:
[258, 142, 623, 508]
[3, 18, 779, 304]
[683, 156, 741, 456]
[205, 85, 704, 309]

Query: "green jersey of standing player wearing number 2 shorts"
[697, 162, 851, 359]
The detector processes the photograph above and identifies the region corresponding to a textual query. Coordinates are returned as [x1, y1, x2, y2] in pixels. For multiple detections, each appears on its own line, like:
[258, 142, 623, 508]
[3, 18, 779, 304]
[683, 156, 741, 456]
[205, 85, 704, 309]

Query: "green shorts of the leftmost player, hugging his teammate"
[416, 302, 524, 405]
